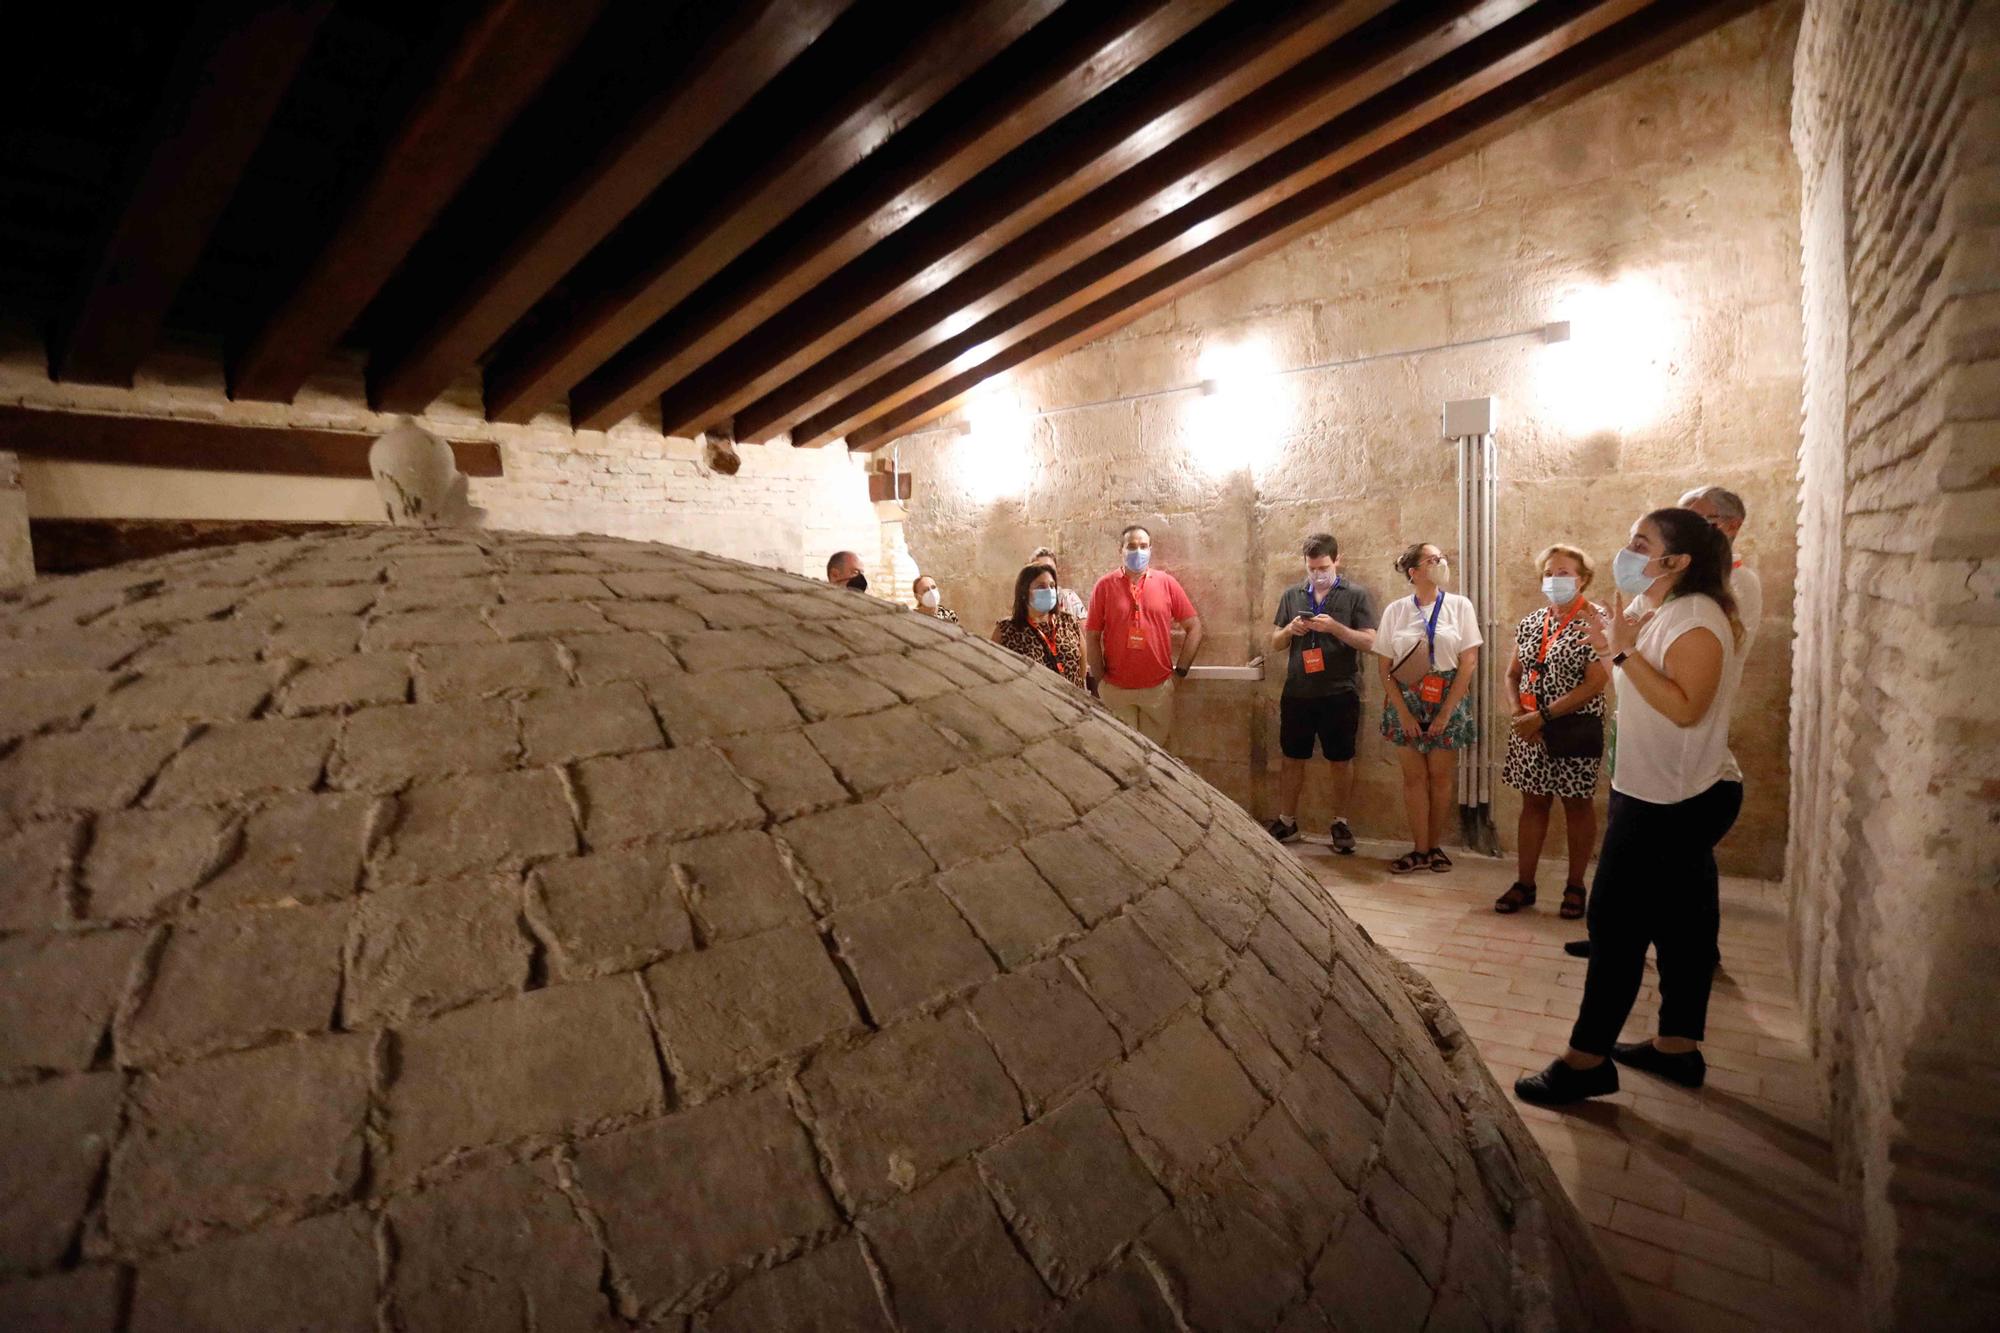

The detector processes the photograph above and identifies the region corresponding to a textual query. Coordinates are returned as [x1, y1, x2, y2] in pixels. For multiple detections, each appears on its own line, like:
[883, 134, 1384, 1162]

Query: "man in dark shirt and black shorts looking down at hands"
[1270, 532, 1374, 857]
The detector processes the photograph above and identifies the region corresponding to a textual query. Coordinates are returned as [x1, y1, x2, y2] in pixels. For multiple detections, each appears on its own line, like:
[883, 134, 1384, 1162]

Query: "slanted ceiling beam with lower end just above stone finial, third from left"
[368, 0, 852, 412]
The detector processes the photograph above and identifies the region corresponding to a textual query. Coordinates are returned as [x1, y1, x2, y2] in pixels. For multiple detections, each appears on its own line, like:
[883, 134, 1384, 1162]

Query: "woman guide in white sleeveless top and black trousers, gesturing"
[1514, 508, 1744, 1105]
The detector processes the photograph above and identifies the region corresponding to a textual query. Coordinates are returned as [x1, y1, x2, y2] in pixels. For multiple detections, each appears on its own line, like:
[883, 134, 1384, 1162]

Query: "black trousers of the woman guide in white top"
[1570, 783, 1744, 1055]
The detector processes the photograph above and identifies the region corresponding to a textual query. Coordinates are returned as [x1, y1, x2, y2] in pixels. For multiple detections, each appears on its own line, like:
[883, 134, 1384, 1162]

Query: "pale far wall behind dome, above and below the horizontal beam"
[0, 330, 882, 576]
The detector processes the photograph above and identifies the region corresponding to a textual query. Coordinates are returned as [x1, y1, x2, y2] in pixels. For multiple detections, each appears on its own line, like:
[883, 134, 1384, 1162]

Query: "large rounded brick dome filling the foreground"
[0, 528, 1622, 1333]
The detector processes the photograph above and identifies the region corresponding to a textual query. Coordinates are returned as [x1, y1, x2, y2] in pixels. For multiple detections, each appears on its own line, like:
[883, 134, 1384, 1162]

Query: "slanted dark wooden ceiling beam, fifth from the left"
[570, 0, 1254, 434]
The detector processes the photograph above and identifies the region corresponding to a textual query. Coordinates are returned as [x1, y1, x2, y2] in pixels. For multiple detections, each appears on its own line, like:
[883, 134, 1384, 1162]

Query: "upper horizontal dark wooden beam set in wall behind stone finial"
[0, 406, 500, 476]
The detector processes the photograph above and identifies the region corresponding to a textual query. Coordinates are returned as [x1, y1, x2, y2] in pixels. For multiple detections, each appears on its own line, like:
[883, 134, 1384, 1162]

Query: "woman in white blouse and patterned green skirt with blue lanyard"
[1374, 542, 1482, 875]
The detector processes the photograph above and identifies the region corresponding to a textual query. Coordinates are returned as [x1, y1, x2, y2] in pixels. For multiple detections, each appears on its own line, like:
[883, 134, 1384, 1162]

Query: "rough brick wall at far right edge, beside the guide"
[1790, 0, 2000, 1327]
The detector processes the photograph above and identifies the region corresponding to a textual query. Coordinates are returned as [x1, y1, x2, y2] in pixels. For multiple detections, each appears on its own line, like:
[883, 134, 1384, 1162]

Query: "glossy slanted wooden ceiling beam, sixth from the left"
[608, 0, 1390, 434]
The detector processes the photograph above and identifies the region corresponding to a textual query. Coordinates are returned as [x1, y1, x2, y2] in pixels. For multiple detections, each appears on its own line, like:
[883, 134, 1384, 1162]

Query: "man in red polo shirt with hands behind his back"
[1084, 524, 1202, 747]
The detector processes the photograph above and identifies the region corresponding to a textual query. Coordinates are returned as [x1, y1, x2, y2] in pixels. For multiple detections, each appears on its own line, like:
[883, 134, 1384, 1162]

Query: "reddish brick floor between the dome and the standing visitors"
[1292, 843, 1856, 1333]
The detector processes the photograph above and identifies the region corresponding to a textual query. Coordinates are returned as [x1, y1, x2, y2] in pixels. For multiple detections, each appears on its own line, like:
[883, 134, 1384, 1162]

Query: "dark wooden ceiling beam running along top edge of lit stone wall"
[848, 0, 1766, 450]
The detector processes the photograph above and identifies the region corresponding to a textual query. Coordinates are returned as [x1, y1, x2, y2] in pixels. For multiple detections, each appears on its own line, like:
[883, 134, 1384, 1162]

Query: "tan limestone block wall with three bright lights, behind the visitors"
[902, 6, 1800, 877]
